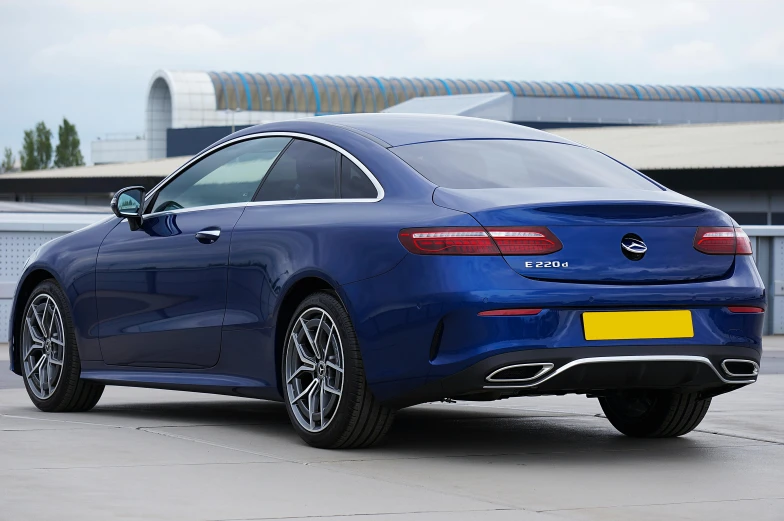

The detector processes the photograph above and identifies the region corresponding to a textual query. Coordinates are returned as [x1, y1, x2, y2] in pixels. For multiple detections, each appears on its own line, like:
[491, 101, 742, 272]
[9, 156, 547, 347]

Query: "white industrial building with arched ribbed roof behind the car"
[92, 70, 784, 164]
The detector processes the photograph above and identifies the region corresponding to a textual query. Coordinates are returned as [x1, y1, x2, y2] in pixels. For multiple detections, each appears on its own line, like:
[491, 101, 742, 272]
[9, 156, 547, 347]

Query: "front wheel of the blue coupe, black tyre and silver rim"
[18, 279, 104, 412]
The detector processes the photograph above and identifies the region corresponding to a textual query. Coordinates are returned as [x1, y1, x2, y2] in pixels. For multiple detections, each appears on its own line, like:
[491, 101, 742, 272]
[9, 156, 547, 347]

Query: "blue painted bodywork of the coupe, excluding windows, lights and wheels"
[6, 114, 765, 408]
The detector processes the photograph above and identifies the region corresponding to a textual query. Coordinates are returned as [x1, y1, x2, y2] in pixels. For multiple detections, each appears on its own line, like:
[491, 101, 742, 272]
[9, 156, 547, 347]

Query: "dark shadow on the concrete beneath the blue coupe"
[85, 400, 712, 464]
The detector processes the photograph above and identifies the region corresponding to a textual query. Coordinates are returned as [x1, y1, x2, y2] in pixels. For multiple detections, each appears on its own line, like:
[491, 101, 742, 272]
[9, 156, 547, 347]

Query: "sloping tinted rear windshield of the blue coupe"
[391, 139, 661, 190]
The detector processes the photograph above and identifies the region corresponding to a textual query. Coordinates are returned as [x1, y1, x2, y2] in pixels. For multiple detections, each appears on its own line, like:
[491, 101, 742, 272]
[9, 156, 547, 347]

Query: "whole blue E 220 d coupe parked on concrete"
[10, 114, 765, 448]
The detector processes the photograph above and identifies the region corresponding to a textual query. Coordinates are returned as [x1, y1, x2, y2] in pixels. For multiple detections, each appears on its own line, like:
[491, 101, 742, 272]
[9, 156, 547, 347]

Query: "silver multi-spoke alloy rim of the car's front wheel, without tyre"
[22, 293, 65, 400]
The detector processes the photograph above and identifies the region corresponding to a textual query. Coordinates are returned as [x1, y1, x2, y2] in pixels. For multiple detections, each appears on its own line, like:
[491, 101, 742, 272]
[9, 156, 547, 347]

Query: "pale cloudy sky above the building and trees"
[0, 0, 784, 163]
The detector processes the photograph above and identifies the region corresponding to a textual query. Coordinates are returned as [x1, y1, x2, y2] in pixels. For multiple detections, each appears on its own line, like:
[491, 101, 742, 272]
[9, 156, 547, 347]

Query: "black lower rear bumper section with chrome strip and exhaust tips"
[392, 345, 761, 407]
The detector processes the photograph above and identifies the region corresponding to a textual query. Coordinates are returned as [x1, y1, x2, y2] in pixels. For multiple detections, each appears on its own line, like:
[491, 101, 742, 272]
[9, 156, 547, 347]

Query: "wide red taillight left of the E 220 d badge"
[398, 226, 563, 255]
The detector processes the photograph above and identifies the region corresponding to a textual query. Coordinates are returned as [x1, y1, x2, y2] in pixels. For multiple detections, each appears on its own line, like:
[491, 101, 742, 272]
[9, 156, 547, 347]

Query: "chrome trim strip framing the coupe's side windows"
[142, 132, 386, 218]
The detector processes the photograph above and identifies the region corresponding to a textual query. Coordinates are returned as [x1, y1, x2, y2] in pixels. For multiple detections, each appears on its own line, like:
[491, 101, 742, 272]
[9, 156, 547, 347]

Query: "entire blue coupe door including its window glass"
[96, 137, 290, 367]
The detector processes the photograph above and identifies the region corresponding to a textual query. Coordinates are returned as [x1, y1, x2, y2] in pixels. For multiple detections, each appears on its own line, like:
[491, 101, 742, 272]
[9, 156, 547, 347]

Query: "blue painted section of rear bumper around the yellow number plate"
[339, 255, 765, 401]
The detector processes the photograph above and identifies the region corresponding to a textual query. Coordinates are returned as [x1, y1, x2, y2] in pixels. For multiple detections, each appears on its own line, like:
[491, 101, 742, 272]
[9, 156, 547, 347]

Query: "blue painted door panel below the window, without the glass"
[95, 207, 243, 367]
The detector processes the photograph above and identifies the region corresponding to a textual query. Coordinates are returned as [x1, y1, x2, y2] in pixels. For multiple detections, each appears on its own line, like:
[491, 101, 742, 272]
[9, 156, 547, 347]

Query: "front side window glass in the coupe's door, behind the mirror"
[150, 137, 291, 212]
